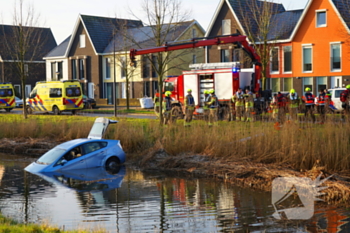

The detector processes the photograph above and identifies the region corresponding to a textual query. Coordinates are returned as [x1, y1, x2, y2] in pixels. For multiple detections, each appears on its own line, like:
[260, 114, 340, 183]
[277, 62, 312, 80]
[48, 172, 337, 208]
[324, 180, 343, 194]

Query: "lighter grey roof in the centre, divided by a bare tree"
[104, 20, 195, 53]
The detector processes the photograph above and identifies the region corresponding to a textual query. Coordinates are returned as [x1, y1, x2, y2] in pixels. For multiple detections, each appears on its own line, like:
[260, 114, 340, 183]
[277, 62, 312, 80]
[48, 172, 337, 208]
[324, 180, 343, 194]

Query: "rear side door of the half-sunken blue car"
[82, 141, 107, 168]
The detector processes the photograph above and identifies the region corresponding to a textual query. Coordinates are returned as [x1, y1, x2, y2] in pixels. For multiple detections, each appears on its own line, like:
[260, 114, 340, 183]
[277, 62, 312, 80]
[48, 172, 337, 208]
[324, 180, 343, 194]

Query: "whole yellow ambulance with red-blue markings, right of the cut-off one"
[26, 80, 84, 115]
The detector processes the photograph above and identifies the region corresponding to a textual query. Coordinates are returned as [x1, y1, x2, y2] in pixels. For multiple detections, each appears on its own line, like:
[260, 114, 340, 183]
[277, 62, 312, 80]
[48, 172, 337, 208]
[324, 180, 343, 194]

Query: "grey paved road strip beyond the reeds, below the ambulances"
[0, 109, 157, 119]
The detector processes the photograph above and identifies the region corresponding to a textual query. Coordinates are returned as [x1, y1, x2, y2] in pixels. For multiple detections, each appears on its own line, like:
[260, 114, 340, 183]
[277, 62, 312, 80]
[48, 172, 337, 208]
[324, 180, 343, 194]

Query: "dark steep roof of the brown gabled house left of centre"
[81, 15, 143, 53]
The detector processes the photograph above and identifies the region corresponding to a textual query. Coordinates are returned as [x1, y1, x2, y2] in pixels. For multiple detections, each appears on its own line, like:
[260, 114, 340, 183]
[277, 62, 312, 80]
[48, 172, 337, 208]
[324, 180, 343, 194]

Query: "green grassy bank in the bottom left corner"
[0, 214, 106, 233]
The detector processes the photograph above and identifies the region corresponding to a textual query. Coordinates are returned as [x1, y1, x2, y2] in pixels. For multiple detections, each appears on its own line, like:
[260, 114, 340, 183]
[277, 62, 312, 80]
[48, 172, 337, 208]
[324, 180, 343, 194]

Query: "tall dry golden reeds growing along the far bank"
[0, 115, 350, 172]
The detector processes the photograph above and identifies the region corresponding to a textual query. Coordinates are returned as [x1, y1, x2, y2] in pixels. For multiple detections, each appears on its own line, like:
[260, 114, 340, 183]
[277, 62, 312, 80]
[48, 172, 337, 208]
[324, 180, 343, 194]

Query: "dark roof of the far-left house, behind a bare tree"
[0, 25, 57, 61]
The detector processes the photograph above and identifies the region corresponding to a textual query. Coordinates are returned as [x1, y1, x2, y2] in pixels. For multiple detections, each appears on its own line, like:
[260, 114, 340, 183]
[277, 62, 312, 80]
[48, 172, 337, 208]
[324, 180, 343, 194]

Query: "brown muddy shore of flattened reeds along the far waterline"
[0, 138, 350, 207]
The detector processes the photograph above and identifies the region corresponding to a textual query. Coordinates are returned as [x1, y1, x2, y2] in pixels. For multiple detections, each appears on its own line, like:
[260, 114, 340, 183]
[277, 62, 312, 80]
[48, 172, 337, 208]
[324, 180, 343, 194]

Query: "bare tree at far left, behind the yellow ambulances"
[2, 0, 47, 119]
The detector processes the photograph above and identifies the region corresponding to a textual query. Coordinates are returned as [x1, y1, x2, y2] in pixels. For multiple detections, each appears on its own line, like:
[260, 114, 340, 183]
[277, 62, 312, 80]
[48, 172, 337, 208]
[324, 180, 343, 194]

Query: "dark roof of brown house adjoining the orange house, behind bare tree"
[227, 0, 286, 37]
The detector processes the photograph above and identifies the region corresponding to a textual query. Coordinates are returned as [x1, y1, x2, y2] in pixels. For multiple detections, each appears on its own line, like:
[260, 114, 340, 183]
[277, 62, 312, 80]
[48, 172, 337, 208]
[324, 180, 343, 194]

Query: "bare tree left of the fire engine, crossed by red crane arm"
[128, 0, 190, 124]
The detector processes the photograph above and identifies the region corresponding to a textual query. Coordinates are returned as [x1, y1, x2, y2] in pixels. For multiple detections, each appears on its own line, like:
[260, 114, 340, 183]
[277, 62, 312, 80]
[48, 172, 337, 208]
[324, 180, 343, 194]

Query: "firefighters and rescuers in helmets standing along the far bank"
[155, 85, 350, 127]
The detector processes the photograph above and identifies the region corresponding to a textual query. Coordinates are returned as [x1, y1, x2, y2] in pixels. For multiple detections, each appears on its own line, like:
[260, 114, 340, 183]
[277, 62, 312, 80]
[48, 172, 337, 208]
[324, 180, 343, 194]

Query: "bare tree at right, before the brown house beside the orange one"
[237, 0, 286, 89]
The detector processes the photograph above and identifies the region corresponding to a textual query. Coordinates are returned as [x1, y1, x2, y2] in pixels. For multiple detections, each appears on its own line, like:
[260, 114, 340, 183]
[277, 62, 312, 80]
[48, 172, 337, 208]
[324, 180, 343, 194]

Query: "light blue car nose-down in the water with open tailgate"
[25, 117, 125, 173]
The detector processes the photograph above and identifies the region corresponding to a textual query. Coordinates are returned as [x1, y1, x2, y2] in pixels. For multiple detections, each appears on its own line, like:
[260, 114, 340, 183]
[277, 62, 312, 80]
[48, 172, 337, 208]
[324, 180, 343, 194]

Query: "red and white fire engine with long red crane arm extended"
[130, 34, 261, 120]
